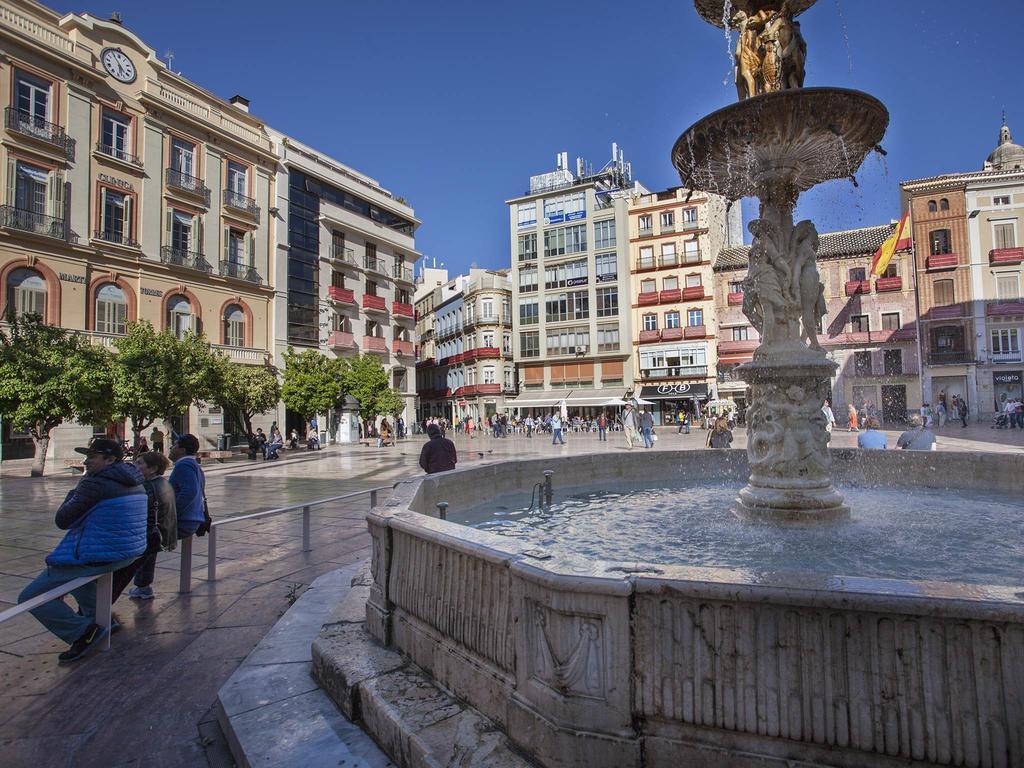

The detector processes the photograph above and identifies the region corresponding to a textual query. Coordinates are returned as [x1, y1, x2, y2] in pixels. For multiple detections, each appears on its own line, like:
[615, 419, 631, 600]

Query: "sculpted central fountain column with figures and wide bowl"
[672, 0, 889, 520]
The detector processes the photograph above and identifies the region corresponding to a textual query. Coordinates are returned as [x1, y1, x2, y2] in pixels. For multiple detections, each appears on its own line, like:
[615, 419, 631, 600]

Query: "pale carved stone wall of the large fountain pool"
[367, 451, 1024, 768]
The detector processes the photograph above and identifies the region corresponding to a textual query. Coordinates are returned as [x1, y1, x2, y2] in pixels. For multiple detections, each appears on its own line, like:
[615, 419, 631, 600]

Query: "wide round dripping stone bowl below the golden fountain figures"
[672, 88, 889, 200]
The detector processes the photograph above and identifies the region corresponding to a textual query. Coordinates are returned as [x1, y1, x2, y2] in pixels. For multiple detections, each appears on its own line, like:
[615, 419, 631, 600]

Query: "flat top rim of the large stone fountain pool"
[382, 449, 1024, 621]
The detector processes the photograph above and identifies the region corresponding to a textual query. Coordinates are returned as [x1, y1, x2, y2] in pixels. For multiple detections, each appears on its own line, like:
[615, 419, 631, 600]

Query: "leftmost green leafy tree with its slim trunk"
[0, 315, 112, 477]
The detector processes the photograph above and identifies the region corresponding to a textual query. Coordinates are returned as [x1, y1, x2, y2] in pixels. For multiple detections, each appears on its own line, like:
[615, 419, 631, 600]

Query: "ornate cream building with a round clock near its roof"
[0, 0, 276, 458]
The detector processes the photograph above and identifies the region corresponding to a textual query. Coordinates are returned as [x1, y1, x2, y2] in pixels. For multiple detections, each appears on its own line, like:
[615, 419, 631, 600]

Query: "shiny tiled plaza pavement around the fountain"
[0, 425, 1024, 768]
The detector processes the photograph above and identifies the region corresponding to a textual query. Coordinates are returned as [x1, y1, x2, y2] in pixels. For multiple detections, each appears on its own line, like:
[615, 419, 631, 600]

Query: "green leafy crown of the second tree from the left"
[113, 322, 218, 444]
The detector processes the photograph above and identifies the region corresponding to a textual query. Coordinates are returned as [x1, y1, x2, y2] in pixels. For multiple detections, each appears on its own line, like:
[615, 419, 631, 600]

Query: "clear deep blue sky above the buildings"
[50, 0, 1024, 270]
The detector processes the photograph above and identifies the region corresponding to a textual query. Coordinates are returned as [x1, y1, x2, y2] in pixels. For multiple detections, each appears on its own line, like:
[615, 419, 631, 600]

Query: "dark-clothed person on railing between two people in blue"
[124, 454, 179, 600]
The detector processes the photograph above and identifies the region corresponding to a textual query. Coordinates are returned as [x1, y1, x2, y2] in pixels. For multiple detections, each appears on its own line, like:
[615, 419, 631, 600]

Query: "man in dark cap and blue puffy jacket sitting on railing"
[17, 438, 146, 664]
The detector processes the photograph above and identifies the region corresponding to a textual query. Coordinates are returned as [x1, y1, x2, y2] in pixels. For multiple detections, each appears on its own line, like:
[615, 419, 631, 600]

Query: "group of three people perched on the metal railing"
[17, 430, 211, 665]
